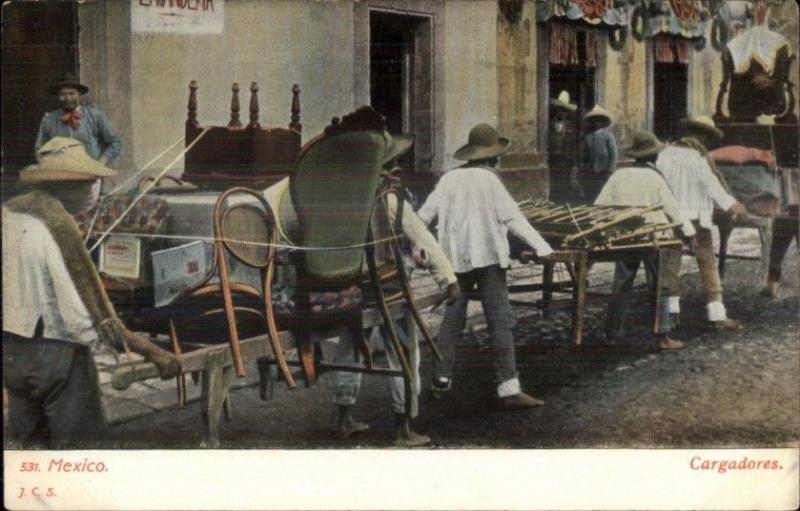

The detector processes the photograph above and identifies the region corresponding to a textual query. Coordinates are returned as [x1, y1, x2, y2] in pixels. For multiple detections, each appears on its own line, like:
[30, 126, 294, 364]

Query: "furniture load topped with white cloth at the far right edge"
[711, 24, 800, 275]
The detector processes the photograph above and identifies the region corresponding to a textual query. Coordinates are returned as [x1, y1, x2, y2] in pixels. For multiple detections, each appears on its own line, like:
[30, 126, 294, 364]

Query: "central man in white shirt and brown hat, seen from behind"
[418, 124, 552, 408]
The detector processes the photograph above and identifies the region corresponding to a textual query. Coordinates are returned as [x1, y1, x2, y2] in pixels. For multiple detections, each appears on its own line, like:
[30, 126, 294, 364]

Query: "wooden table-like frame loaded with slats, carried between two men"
[508, 201, 682, 347]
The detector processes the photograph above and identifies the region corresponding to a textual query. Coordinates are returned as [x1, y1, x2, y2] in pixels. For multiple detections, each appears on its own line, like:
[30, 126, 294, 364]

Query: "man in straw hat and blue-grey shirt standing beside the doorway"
[578, 105, 617, 202]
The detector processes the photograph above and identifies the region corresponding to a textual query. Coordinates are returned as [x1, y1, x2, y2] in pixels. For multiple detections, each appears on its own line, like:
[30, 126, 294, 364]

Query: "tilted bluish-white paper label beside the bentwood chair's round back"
[153, 241, 214, 307]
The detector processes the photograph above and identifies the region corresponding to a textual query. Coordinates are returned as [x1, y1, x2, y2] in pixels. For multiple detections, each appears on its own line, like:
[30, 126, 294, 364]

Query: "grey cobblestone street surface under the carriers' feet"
[103, 230, 800, 448]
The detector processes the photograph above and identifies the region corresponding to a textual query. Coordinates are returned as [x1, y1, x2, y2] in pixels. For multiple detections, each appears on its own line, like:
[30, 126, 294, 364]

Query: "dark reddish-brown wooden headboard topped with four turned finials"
[181, 80, 302, 190]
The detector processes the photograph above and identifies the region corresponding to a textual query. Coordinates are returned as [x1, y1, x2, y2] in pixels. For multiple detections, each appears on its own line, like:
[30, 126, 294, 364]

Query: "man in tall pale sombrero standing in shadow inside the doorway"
[547, 91, 578, 202]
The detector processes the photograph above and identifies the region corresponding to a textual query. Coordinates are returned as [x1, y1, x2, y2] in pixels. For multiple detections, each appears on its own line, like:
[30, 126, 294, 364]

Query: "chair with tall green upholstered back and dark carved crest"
[289, 108, 396, 386]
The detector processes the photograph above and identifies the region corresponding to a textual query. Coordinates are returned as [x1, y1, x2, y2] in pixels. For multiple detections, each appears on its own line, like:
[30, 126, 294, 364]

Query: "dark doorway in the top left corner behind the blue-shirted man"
[2, 0, 78, 182]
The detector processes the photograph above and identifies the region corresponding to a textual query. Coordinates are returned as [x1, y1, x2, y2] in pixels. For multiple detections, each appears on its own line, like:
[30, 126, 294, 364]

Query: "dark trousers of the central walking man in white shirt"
[433, 264, 517, 384]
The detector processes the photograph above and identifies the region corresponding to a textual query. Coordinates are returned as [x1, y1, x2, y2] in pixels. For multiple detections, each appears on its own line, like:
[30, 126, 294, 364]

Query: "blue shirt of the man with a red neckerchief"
[34, 106, 122, 161]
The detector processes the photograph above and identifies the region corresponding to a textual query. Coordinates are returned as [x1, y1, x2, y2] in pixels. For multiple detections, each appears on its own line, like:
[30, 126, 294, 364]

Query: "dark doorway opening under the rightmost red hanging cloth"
[653, 62, 689, 141]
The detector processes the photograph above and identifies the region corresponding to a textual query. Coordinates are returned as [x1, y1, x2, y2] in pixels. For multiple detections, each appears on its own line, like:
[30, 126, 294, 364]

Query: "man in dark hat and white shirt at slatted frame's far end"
[595, 131, 695, 349]
